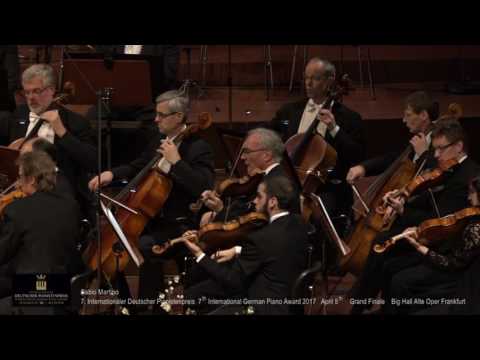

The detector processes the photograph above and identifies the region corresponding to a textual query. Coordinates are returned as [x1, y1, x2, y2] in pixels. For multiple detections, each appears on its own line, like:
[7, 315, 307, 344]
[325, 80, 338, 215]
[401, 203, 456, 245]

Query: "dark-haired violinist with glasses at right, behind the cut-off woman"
[351, 118, 480, 313]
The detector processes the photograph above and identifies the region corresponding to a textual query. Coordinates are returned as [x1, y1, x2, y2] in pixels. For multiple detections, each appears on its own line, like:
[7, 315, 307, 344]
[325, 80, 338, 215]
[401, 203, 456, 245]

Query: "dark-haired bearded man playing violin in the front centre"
[185, 176, 308, 315]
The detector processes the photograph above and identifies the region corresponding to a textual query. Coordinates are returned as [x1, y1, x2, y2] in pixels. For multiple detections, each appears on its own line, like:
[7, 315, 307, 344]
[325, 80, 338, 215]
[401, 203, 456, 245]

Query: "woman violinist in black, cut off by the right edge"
[384, 177, 480, 314]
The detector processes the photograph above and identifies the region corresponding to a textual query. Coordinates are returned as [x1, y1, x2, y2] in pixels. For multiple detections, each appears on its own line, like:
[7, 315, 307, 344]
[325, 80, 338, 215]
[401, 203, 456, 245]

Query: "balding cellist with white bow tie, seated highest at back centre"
[271, 57, 365, 219]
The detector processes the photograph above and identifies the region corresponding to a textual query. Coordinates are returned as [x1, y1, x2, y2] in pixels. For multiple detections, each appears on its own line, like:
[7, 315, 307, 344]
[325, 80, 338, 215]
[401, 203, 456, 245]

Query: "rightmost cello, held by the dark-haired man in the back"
[339, 104, 462, 276]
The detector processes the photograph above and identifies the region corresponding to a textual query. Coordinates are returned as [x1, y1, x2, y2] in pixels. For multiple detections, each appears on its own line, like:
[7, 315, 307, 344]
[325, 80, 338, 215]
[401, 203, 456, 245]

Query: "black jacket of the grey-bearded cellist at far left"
[2, 105, 97, 210]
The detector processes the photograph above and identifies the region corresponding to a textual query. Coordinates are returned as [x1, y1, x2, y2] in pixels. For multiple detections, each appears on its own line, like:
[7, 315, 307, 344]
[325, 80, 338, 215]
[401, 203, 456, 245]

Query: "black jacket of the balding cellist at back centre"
[270, 99, 365, 210]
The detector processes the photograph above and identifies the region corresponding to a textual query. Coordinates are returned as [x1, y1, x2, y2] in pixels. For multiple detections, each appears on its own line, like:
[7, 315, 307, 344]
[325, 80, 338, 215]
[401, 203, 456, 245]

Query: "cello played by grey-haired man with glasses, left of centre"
[83, 112, 212, 280]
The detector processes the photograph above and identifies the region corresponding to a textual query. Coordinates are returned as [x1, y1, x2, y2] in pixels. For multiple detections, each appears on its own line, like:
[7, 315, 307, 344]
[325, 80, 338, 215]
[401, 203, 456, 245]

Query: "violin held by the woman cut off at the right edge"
[373, 207, 480, 254]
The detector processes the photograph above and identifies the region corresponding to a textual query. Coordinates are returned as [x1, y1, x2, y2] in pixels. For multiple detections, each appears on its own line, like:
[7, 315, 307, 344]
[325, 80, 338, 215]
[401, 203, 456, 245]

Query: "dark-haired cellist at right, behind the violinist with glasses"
[347, 91, 439, 183]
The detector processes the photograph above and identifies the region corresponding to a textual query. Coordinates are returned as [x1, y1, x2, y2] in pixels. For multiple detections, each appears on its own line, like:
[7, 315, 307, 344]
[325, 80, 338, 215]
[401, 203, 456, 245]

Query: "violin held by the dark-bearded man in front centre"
[152, 212, 268, 255]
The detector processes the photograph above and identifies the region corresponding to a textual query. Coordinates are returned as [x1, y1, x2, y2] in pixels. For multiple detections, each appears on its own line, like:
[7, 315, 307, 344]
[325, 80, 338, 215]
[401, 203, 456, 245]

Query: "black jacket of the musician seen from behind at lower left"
[0, 192, 83, 295]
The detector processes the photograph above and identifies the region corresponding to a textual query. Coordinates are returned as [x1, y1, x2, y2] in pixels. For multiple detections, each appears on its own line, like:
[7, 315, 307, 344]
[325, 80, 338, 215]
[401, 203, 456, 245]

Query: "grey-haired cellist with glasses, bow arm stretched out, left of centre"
[89, 90, 214, 298]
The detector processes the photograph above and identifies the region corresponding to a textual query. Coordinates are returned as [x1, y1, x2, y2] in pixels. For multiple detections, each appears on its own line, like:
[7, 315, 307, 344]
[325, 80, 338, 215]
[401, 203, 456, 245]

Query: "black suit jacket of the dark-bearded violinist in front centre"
[199, 214, 308, 315]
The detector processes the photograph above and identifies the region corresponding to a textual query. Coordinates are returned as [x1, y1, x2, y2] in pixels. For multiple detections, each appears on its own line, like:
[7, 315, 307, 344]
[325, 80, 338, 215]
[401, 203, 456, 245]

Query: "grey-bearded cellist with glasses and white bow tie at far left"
[2, 64, 97, 218]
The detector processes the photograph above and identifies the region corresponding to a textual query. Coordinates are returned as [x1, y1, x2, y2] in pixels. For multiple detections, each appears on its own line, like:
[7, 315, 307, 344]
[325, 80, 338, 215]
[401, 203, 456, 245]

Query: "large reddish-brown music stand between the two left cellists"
[60, 51, 164, 168]
